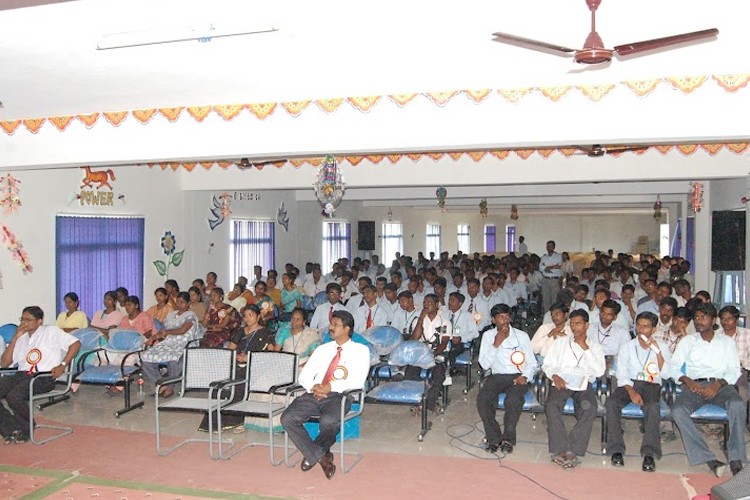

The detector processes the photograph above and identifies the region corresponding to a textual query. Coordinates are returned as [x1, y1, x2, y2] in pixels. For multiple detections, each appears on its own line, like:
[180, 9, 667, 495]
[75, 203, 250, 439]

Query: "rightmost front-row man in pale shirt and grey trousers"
[669, 303, 747, 477]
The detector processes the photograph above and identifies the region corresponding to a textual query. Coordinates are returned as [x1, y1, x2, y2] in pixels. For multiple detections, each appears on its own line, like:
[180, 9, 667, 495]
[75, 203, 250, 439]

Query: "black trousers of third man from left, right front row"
[607, 380, 661, 459]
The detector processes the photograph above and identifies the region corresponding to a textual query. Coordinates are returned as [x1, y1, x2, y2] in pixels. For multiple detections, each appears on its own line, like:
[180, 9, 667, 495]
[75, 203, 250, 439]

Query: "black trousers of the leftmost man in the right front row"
[477, 373, 529, 446]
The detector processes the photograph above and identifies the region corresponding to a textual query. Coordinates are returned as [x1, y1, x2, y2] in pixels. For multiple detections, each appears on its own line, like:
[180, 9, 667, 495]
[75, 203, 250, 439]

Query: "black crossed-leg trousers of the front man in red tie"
[281, 392, 352, 464]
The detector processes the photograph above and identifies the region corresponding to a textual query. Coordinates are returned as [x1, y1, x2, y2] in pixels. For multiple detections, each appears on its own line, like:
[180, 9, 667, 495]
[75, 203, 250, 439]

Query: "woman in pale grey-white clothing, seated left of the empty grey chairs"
[141, 292, 202, 398]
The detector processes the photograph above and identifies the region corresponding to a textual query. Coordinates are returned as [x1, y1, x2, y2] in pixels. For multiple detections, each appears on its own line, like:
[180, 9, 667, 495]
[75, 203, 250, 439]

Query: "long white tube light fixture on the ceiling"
[96, 24, 278, 50]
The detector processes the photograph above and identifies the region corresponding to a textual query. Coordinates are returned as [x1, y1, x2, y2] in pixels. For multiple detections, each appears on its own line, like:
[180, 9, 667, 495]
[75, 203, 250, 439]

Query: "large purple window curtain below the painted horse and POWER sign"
[55, 215, 144, 318]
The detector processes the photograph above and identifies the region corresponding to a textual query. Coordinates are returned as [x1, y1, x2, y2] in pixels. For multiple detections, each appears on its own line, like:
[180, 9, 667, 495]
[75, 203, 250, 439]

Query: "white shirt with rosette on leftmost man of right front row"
[479, 327, 538, 382]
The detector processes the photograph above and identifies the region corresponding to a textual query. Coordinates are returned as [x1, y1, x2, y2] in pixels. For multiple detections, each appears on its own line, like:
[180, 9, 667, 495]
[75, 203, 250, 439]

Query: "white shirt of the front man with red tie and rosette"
[299, 340, 370, 393]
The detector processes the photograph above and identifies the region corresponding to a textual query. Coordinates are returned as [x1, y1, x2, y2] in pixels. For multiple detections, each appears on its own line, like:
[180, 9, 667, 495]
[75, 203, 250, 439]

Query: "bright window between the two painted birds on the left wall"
[229, 219, 276, 283]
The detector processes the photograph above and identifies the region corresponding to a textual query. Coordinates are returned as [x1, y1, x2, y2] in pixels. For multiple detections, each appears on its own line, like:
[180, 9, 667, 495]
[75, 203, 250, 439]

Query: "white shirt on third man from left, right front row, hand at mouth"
[615, 338, 671, 387]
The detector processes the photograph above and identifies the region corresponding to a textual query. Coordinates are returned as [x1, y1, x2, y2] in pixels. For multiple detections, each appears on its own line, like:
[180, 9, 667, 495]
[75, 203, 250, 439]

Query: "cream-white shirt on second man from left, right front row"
[542, 336, 606, 391]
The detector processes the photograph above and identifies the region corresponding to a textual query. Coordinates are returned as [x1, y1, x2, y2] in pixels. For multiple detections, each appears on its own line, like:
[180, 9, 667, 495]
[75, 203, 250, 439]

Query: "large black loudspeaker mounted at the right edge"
[711, 210, 745, 271]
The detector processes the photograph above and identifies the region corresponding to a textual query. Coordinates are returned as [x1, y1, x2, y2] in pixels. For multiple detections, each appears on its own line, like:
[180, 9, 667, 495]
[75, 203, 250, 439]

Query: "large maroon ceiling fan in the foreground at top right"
[492, 0, 719, 64]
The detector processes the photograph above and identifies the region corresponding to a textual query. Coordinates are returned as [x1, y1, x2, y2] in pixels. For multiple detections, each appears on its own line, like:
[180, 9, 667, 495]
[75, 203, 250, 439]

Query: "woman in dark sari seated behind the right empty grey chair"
[198, 304, 277, 432]
